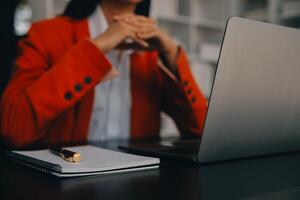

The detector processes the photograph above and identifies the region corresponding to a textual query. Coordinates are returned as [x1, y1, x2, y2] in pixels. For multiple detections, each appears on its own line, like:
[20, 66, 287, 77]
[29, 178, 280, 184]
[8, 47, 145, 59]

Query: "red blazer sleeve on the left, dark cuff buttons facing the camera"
[0, 25, 112, 146]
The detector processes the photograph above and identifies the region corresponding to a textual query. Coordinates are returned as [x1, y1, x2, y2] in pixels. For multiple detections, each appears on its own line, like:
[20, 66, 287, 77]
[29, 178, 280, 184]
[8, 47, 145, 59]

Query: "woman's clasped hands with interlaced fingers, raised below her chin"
[92, 14, 178, 69]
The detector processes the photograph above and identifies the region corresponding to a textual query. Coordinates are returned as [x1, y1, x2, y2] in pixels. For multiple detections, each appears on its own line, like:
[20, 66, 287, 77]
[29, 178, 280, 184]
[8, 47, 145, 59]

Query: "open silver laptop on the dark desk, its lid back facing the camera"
[123, 17, 300, 163]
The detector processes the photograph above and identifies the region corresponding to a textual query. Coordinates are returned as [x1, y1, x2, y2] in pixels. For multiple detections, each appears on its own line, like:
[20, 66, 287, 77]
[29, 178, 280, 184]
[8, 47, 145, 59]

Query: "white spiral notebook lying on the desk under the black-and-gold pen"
[6, 145, 160, 177]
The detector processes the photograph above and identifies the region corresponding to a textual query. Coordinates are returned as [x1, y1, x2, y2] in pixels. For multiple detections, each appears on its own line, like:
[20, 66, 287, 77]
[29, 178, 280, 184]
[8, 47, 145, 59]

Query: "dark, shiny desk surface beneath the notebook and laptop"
[0, 142, 300, 200]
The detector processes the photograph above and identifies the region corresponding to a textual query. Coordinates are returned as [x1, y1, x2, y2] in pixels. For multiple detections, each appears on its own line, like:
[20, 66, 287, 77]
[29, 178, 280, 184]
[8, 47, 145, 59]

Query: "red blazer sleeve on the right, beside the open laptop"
[161, 48, 207, 136]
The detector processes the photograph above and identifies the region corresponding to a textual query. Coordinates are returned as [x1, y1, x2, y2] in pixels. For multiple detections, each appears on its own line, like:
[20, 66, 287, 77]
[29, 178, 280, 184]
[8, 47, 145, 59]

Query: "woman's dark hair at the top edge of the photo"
[63, 0, 150, 19]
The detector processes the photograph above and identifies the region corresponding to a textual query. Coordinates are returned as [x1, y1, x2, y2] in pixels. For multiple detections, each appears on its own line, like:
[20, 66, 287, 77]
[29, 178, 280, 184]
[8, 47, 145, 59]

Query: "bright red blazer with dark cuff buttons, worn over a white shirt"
[0, 17, 207, 147]
